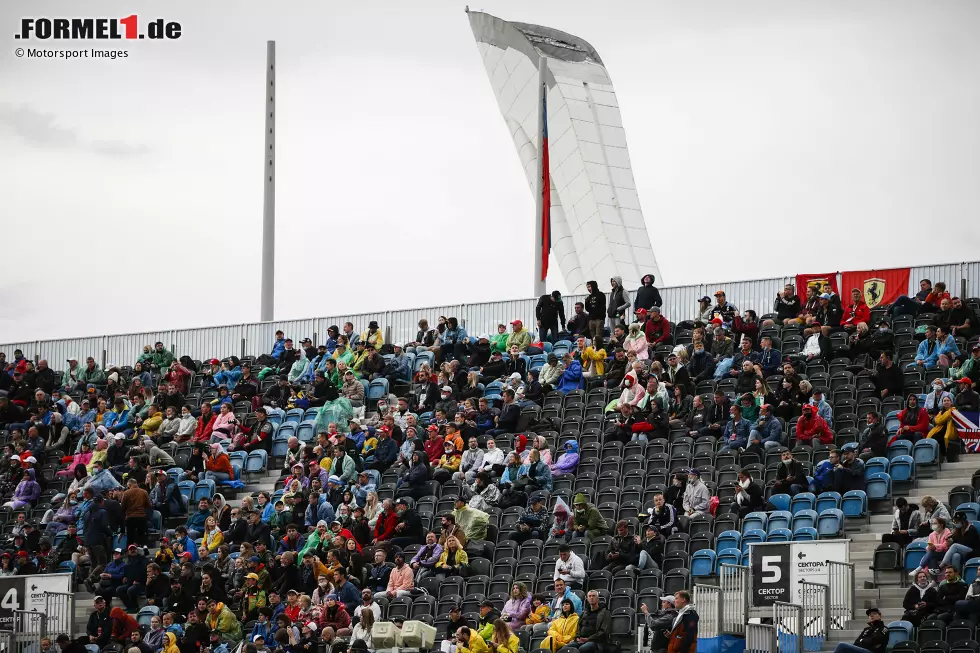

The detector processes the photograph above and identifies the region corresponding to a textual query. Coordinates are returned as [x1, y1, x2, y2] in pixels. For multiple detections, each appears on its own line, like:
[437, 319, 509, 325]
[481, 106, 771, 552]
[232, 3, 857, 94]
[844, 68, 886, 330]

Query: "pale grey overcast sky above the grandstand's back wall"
[0, 0, 980, 342]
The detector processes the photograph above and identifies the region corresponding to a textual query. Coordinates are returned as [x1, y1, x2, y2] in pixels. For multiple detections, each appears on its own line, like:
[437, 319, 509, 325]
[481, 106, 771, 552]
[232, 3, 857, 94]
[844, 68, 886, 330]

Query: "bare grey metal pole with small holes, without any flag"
[259, 41, 276, 322]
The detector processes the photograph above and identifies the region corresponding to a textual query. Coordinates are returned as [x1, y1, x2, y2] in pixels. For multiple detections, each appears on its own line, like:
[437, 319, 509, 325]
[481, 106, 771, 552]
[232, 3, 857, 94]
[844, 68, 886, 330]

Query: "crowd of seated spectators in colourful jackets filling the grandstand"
[0, 275, 980, 653]
